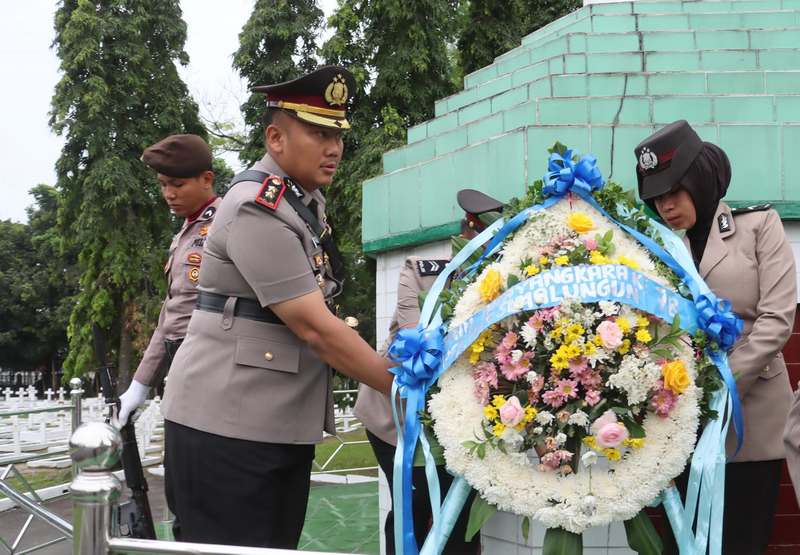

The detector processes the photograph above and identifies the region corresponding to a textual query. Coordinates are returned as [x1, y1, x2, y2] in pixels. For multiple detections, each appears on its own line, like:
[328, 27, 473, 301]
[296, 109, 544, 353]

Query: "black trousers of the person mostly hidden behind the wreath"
[367, 430, 481, 555]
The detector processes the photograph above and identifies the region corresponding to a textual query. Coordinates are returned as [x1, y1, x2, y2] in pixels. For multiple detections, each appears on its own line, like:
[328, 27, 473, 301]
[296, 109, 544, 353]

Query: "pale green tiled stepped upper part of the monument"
[362, 0, 800, 254]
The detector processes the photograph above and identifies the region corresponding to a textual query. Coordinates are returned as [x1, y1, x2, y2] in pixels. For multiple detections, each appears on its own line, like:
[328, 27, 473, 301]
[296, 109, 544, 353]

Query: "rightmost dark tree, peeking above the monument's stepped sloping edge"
[458, 0, 581, 75]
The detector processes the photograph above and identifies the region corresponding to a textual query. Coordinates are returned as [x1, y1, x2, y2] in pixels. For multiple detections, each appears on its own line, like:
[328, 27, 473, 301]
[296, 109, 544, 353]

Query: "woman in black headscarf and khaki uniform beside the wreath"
[635, 120, 797, 555]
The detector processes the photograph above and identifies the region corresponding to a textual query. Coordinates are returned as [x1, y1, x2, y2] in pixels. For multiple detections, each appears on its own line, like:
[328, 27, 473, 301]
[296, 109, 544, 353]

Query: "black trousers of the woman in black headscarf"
[661, 459, 783, 555]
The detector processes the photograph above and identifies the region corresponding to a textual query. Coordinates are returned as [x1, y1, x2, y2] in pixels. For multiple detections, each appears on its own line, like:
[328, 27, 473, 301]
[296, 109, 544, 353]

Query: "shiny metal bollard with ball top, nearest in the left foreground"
[69, 422, 122, 555]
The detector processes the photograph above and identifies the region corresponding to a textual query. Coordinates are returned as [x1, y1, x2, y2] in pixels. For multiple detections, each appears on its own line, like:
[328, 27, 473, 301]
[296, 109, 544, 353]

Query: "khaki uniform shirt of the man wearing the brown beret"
[133, 198, 221, 387]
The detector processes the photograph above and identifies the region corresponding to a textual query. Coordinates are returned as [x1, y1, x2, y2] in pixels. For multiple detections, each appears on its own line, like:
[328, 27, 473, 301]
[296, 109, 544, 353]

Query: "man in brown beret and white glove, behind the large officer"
[119, 135, 220, 424]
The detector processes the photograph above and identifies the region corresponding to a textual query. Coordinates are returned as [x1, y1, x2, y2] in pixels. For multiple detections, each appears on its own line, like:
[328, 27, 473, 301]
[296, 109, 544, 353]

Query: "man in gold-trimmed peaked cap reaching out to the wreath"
[162, 66, 393, 549]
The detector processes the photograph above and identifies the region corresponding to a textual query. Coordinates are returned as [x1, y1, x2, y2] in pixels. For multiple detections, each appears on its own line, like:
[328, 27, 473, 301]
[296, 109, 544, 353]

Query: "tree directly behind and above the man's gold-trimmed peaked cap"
[233, 0, 323, 165]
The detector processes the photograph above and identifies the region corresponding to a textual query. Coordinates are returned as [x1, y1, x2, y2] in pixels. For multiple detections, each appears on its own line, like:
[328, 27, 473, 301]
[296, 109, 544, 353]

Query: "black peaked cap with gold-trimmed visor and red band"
[252, 66, 356, 129]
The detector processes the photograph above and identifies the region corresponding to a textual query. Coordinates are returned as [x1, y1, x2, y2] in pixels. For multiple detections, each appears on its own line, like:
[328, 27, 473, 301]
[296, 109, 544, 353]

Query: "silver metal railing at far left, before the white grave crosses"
[0, 378, 83, 555]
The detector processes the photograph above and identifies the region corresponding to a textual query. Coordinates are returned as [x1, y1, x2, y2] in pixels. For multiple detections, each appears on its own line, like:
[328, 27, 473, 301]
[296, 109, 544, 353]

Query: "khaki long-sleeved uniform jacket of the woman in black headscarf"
[688, 202, 797, 462]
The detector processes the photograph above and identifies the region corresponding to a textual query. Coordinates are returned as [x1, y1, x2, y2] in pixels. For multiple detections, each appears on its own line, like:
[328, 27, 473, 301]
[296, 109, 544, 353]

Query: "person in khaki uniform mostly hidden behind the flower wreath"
[353, 189, 503, 555]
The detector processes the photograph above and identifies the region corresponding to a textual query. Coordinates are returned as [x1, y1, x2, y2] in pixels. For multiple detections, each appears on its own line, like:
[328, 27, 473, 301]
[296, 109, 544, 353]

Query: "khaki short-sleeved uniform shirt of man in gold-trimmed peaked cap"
[162, 155, 341, 444]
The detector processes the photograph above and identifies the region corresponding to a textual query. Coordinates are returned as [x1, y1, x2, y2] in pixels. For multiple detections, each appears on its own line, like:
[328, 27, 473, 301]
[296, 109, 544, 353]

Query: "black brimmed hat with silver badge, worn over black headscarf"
[633, 120, 703, 201]
